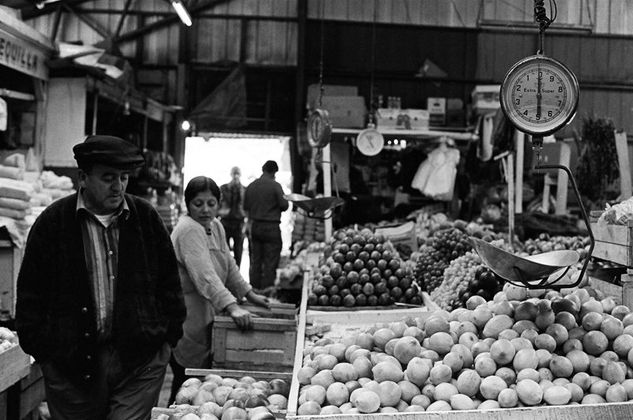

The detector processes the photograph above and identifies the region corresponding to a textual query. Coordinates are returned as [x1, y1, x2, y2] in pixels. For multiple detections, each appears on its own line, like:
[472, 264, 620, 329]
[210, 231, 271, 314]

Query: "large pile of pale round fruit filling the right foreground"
[297, 284, 633, 415]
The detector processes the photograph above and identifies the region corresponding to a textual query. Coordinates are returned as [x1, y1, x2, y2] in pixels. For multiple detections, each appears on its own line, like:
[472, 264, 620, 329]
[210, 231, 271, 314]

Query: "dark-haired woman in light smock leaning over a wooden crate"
[169, 176, 269, 404]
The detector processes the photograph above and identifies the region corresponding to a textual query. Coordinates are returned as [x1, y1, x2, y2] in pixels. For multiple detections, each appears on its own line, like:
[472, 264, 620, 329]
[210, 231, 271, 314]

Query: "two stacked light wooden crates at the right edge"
[590, 211, 633, 308]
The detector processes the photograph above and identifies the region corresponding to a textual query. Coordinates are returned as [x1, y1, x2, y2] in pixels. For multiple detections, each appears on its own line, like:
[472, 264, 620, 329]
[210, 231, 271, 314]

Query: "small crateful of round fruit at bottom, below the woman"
[164, 373, 290, 420]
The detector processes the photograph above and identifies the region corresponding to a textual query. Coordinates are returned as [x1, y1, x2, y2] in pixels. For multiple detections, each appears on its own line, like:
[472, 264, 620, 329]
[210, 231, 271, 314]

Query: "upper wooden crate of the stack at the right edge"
[590, 211, 633, 267]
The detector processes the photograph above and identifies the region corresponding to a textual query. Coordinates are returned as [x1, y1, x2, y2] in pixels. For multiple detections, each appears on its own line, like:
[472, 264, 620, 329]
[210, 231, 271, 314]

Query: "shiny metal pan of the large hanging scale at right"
[469, 237, 580, 283]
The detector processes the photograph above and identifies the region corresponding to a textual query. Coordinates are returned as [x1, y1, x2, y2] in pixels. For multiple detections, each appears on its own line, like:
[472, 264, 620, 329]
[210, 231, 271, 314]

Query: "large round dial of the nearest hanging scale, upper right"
[500, 55, 578, 136]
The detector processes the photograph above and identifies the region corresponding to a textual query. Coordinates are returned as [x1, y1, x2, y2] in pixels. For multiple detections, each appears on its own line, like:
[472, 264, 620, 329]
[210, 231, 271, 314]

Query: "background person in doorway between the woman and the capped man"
[219, 166, 246, 267]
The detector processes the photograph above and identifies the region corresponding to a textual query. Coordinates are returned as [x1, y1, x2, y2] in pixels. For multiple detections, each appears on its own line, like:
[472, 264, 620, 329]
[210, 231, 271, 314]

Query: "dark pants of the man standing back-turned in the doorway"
[248, 221, 282, 290]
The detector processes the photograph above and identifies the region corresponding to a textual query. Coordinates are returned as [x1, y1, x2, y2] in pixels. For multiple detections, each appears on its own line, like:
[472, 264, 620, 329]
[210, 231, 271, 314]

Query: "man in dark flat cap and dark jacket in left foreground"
[16, 135, 185, 420]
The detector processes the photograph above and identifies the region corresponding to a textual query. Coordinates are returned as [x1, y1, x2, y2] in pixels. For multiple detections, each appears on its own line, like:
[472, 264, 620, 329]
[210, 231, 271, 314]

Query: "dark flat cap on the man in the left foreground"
[73, 135, 145, 169]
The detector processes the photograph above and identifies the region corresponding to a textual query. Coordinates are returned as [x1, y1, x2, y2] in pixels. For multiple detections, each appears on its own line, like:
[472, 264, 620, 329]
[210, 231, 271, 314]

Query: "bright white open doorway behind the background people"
[183, 133, 292, 281]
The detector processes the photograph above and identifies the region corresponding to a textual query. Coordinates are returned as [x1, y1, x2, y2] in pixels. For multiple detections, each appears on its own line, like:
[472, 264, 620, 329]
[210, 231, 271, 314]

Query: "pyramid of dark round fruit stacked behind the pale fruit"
[308, 228, 422, 307]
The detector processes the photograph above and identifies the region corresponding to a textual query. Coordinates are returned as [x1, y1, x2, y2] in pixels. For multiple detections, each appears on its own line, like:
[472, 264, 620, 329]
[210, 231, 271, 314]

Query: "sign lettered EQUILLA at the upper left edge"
[0, 29, 48, 80]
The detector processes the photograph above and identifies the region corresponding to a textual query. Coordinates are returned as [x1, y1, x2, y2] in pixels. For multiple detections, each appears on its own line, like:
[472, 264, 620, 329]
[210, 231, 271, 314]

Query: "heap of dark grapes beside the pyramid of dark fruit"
[415, 228, 472, 293]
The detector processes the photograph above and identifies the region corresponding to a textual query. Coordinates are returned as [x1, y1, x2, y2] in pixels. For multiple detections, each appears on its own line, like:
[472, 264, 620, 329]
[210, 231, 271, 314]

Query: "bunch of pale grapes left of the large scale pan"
[431, 251, 483, 311]
